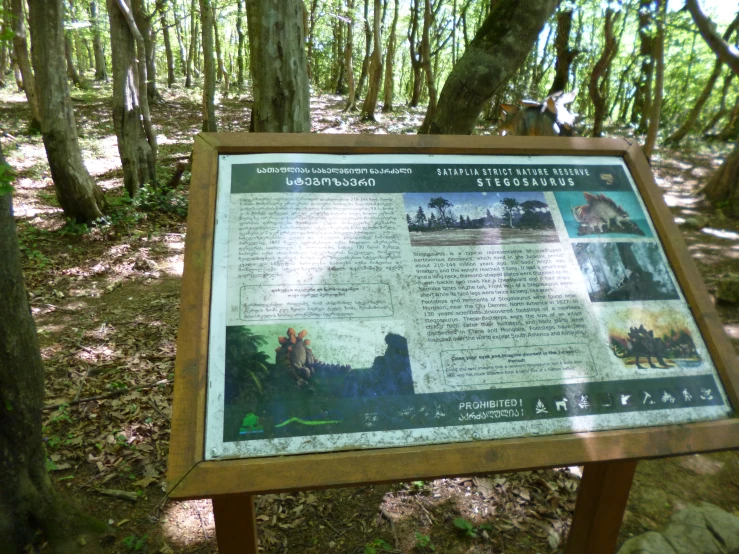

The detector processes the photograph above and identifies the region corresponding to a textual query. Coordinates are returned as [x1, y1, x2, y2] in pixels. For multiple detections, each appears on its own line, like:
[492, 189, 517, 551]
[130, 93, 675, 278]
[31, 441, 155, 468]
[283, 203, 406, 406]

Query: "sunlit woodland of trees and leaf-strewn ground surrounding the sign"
[0, 0, 739, 553]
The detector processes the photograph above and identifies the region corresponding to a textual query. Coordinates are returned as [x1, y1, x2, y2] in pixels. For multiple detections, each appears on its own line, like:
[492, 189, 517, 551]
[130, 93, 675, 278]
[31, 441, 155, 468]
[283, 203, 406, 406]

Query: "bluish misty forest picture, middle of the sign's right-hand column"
[572, 242, 680, 302]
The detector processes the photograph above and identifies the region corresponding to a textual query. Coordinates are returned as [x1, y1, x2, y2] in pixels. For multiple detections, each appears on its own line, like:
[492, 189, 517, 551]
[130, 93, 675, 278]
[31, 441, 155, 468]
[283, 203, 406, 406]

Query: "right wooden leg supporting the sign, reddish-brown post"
[565, 460, 636, 554]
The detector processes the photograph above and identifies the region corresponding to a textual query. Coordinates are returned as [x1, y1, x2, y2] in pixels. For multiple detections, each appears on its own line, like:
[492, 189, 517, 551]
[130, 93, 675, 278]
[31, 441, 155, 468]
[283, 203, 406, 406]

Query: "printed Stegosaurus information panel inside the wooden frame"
[205, 154, 731, 459]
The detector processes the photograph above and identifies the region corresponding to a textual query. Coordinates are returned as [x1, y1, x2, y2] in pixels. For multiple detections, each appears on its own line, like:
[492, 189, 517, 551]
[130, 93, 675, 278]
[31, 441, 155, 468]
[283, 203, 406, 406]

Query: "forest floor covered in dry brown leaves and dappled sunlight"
[0, 82, 739, 554]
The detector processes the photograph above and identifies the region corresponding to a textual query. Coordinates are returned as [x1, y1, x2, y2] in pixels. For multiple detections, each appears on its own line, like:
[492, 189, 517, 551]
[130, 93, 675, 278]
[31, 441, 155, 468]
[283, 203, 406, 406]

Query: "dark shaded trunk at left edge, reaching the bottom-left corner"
[0, 143, 66, 552]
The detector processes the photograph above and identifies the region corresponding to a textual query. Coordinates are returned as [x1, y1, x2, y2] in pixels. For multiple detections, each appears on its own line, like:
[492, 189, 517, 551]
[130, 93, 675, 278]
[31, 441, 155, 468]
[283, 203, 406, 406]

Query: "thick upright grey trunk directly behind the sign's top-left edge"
[246, 0, 310, 133]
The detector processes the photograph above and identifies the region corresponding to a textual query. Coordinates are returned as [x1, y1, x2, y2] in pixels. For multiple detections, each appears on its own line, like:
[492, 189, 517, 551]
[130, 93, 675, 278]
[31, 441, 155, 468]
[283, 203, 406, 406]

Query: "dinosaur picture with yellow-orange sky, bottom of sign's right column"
[605, 308, 703, 371]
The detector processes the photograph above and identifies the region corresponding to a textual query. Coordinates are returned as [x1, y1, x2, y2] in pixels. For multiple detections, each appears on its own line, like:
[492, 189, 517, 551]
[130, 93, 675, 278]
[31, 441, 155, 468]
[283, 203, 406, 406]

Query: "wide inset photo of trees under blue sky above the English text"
[403, 192, 559, 246]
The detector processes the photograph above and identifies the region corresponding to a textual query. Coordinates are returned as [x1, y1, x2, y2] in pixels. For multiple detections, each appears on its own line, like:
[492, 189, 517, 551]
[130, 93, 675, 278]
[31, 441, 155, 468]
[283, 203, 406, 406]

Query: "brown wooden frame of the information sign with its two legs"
[168, 133, 739, 552]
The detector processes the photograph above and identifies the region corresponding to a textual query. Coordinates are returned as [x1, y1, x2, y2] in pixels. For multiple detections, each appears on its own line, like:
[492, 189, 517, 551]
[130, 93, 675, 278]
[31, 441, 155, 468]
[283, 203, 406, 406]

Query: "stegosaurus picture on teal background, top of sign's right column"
[554, 191, 652, 238]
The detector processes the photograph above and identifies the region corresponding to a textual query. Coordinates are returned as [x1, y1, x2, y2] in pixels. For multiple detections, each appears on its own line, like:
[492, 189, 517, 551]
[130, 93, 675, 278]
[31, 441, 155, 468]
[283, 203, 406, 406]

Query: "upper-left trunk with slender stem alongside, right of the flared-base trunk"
[107, 0, 156, 198]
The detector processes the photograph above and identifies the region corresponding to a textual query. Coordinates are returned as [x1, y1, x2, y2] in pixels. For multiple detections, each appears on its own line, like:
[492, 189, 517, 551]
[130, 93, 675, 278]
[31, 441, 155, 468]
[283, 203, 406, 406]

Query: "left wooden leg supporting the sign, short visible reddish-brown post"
[213, 494, 258, 554]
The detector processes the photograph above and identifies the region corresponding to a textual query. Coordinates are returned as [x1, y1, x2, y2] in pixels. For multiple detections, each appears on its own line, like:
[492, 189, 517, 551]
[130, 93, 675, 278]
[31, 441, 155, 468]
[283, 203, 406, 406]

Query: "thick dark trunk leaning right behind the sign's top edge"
[420, 0, 558, 135]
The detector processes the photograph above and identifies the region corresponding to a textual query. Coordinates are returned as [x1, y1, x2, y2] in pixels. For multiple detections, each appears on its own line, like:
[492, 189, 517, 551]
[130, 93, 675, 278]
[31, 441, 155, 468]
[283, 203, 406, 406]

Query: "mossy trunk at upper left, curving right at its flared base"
[28, 0, 106, 223]
